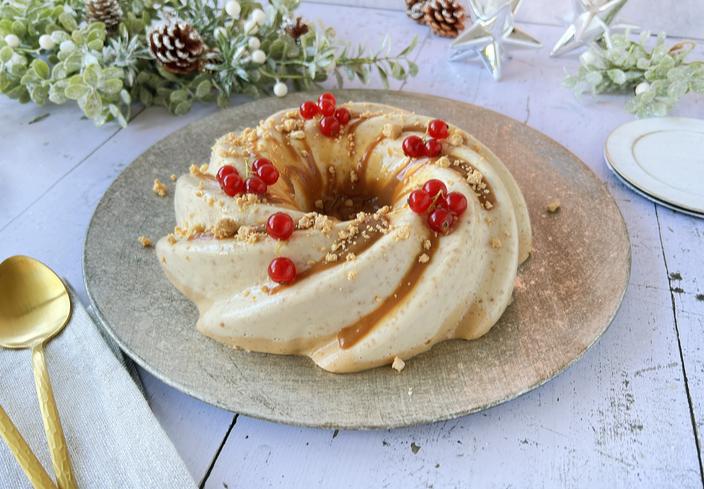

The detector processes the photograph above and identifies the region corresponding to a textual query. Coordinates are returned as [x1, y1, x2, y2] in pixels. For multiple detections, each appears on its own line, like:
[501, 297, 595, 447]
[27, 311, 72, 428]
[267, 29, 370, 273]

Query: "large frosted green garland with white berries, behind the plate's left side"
[0, 0, 418, 126]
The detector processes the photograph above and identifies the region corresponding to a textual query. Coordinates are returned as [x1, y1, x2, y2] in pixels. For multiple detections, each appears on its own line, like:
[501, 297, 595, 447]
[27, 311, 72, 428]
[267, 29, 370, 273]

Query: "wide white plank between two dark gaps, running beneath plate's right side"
[206, 21, 702, 488]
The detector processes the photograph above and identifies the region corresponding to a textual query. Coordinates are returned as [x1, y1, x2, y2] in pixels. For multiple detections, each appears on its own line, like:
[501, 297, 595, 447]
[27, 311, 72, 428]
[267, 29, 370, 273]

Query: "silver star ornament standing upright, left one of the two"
[450, 0, 542, 80]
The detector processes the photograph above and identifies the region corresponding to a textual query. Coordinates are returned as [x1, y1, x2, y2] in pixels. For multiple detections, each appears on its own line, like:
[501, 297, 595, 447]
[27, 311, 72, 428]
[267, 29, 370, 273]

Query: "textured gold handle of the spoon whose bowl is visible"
[32, 343, 77, 489]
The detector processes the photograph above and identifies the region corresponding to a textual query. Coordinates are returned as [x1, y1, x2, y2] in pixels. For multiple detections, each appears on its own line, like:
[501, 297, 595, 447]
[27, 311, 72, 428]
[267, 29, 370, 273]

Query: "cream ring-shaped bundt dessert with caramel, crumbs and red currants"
[157, 94, 531, 372]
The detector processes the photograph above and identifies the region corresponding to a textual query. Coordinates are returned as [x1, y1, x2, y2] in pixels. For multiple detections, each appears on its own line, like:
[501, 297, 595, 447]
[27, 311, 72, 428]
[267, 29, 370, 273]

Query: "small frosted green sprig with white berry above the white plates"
[565, 32, 704, 117]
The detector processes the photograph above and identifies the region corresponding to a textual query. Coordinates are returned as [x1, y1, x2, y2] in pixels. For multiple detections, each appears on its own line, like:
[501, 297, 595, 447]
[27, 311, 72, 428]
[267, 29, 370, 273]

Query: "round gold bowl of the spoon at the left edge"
[0, 256, 71, 348]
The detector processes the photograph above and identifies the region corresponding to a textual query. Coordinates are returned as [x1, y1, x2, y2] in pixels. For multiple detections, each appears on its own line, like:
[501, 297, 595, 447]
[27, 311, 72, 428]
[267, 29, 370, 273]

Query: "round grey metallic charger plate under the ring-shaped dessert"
[84, 90, 630, 429]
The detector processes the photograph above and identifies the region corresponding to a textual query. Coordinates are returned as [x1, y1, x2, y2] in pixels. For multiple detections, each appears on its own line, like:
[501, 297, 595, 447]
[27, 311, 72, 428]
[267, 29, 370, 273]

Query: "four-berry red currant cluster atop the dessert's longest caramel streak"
[408, 178, 467, 234]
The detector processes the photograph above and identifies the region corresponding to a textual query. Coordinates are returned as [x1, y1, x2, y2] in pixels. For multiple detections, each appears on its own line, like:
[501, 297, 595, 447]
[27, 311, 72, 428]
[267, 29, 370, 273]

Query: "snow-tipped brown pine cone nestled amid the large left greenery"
[147, 20, 205, 75]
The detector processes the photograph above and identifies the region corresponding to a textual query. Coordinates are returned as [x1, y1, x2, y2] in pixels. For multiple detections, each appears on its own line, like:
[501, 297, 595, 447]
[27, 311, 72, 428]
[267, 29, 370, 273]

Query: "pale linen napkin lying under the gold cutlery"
[0, 288, 195, 489]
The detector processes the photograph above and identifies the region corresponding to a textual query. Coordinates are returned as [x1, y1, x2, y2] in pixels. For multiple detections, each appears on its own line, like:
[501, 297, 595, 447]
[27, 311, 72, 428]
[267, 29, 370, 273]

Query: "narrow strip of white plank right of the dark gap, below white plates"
[657, 206, 704, 470]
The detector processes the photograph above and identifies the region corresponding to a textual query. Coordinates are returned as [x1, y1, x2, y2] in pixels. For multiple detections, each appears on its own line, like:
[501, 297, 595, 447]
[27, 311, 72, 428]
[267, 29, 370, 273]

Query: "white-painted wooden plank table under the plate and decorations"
[0, 0, 704, 489]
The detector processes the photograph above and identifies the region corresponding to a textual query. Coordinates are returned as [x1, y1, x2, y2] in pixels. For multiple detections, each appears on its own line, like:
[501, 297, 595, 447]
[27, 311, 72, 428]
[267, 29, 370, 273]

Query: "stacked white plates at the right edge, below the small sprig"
[604, 117, 704, 218]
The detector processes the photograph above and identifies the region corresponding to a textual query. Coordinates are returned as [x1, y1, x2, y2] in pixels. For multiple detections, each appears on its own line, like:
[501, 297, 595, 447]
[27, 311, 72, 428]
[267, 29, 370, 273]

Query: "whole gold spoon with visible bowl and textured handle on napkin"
[0, 256, 76, 489]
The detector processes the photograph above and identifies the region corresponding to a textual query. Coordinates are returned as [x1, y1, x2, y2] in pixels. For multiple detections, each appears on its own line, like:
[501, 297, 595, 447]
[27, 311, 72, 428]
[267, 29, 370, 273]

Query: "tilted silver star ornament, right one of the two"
[550, 0, 627, 56]
